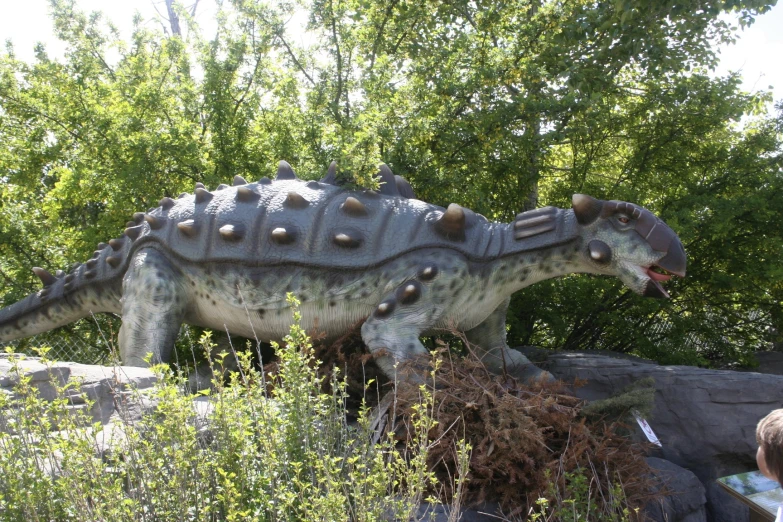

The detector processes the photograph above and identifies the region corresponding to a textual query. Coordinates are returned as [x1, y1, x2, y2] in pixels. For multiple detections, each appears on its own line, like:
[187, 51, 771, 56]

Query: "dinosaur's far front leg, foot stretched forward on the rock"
[465, 299, 554, 382]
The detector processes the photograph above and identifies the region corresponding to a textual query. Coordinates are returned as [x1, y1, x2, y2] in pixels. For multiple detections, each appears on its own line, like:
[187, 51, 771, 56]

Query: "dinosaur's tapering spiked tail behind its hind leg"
[0, 265, 122, 342]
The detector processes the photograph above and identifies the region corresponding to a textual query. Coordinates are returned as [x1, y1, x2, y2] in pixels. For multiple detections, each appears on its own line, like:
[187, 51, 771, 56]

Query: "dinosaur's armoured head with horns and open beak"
[572, 194, 686, 298]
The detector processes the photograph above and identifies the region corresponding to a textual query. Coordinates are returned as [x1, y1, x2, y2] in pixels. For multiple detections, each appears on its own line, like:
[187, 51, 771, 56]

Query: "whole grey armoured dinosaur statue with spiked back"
[0, 162, 686, 379]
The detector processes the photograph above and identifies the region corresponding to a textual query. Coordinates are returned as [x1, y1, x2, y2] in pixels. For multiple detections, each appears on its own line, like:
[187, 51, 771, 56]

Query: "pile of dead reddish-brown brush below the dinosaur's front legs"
[390, 346, 655, 521]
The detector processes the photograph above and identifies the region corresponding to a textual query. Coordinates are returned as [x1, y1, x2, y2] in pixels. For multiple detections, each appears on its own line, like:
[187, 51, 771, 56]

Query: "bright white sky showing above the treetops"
[0, 0, 783, 110]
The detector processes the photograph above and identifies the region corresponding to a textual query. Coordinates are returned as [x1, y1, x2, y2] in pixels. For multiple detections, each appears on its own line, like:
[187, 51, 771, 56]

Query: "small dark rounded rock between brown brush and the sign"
[645, 457, 707, 522]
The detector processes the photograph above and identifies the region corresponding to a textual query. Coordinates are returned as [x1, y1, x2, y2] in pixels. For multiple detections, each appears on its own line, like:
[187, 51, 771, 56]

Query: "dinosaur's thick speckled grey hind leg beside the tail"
[119, 248, 187, 366]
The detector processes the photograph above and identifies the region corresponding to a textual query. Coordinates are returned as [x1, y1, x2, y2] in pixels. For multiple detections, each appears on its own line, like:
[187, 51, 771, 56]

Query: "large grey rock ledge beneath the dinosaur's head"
[544, 353, 783, 522]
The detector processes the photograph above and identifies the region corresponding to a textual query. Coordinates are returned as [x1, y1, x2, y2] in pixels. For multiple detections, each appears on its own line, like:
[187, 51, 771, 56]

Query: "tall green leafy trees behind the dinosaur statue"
[0, 0, 783, 365]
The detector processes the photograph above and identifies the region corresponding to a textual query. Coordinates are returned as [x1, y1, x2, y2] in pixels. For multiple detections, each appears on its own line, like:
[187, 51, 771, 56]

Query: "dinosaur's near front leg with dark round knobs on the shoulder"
[362, 281, 443, 380]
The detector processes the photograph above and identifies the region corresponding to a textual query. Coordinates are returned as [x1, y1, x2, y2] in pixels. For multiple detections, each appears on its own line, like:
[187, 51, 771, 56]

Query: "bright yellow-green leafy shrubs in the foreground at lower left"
[0, 296, 434, 521]
